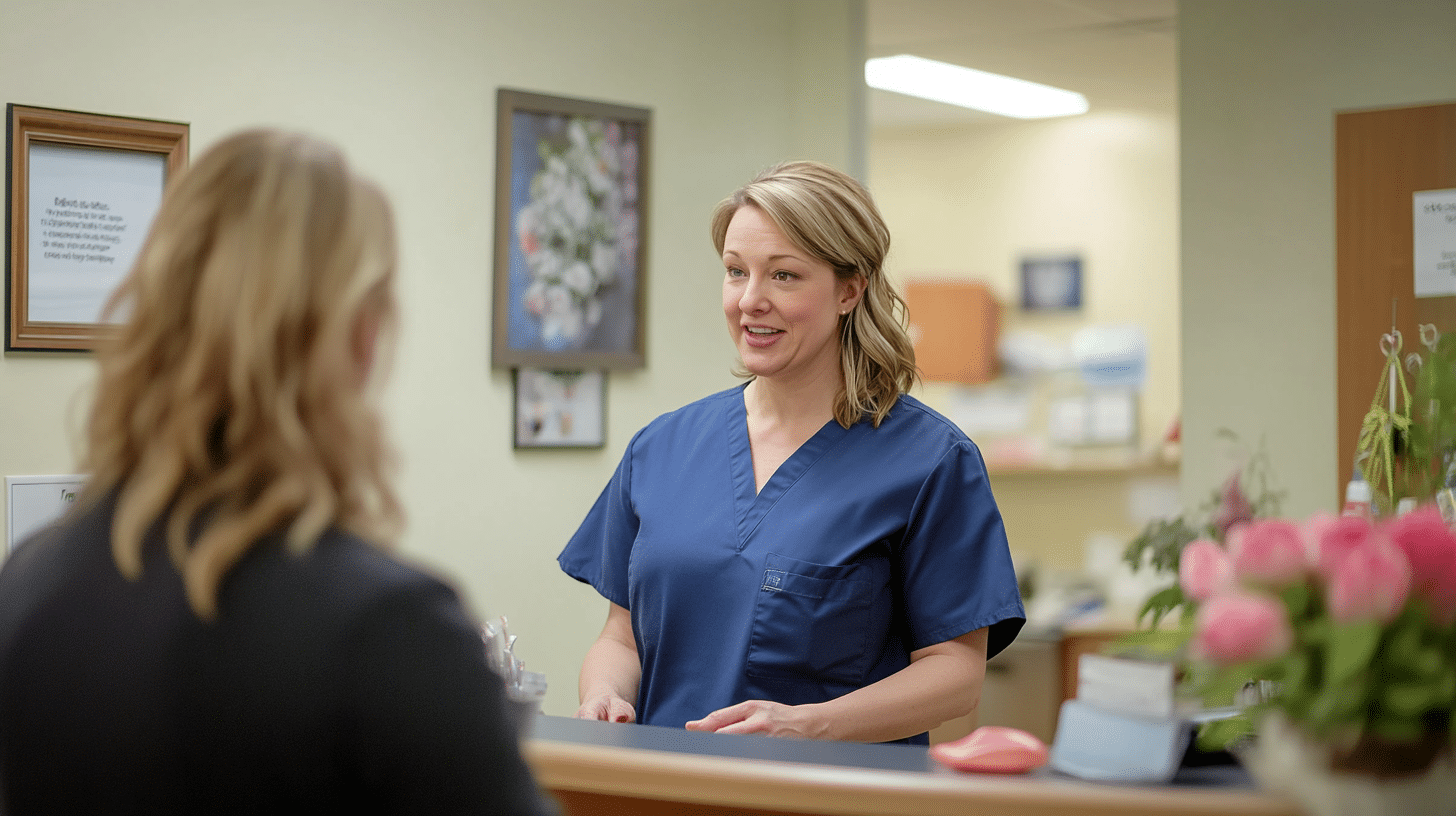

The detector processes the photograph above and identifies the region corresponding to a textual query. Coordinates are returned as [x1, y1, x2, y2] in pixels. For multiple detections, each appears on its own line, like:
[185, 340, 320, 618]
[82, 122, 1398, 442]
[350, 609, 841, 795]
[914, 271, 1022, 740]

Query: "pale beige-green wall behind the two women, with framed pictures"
[0, 0, 863, 714]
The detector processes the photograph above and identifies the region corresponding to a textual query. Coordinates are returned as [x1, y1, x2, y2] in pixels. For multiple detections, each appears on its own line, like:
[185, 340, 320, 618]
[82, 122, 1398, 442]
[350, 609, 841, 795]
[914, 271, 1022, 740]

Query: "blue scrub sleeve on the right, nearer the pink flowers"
[898, 440, 1026, 657]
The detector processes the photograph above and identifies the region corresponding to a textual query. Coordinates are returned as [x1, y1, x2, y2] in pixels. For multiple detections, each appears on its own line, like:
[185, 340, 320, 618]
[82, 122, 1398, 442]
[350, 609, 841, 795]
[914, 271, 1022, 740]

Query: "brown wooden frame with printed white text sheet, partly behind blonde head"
[6, 103, 188, 351]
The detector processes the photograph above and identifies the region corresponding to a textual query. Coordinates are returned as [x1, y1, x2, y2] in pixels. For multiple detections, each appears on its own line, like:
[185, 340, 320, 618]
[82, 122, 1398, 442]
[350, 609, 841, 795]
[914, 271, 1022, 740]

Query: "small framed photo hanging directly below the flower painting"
[515, 369, 607, 447]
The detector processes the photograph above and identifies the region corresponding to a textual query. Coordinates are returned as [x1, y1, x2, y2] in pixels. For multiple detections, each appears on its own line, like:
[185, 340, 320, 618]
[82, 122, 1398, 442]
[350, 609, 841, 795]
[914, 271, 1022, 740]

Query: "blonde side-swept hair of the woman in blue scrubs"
[712, 162, 919, 428]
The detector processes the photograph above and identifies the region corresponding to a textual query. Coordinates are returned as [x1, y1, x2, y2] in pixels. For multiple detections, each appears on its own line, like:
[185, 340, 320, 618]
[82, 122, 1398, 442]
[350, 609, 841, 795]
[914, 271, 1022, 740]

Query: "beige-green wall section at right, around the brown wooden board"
[1178, 0, 1456, 514]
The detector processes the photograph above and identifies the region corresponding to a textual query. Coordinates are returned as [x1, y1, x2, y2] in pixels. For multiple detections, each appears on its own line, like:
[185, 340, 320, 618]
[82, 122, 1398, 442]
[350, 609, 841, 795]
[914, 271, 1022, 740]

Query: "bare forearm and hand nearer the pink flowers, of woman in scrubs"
[684, 629, 987, 742]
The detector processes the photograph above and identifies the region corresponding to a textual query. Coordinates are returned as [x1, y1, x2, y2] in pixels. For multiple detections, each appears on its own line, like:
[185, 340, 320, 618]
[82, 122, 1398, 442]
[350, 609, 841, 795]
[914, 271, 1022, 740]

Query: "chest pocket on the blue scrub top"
[747, 554, 877, 683]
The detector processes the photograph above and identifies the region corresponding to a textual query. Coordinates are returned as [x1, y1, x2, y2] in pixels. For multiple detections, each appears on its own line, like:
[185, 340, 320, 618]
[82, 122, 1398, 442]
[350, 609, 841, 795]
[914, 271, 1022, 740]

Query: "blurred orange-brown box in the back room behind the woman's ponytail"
[906, 278, 1000, 385]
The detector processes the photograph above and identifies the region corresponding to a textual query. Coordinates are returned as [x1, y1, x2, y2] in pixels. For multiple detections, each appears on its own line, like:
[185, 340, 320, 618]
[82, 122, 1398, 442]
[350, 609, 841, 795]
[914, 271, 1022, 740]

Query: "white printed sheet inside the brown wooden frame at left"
[26, 143, 167, 323]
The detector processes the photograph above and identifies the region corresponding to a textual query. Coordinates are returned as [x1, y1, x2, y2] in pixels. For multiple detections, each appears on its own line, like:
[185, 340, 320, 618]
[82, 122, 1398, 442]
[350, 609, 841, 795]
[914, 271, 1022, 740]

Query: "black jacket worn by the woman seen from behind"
[0, 501, 553, 816]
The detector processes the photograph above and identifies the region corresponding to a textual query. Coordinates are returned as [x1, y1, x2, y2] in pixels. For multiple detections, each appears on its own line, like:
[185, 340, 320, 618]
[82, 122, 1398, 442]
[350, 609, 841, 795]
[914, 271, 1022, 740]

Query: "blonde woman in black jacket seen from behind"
[0, 130, 553, 816]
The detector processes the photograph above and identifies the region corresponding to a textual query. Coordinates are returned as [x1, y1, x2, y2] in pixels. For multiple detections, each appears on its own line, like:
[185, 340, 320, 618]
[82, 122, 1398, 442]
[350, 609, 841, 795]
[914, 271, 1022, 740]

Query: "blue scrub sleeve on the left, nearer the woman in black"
[556, 431, 642, 609]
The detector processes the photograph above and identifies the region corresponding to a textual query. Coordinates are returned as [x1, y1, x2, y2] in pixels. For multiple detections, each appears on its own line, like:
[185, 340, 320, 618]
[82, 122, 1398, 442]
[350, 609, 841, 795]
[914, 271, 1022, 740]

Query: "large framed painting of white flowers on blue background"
[491, 87, 652, 370]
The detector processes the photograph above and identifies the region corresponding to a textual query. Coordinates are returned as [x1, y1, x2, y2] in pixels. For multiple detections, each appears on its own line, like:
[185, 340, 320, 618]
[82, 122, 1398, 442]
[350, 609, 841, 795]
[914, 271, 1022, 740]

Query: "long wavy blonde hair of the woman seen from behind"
[83, 130, 402, 618]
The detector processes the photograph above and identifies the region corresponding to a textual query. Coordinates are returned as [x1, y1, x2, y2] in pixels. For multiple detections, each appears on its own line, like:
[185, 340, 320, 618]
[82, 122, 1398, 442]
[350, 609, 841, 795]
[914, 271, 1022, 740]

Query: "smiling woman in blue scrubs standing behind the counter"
[559, 162, 1025, 743]
